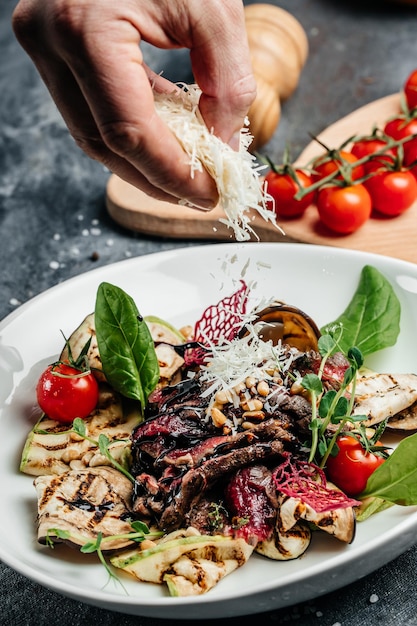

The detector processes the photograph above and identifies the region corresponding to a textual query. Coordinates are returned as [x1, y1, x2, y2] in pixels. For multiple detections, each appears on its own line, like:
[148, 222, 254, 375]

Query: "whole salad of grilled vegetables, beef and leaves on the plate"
[20, 266, 417, 596]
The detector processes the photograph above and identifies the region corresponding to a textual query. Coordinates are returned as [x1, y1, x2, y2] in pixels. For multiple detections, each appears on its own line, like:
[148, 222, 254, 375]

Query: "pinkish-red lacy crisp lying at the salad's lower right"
[273, 456, 360, 513]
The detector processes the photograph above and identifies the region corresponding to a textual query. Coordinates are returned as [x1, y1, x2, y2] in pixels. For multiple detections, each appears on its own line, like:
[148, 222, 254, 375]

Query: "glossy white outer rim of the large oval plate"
[0, 243, 417, 619]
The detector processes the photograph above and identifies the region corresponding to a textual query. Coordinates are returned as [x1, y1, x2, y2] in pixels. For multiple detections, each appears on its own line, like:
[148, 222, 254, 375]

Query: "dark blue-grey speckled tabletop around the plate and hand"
[0, 0, 417, 626]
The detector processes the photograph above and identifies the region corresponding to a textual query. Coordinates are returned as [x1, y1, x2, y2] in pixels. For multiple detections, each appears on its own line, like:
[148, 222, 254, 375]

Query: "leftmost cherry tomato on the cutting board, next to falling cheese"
[265, 169, 315, 217]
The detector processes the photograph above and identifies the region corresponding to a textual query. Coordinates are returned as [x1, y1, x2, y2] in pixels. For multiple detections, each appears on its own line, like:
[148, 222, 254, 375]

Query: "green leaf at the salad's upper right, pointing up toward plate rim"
[321, 265, 401, 356]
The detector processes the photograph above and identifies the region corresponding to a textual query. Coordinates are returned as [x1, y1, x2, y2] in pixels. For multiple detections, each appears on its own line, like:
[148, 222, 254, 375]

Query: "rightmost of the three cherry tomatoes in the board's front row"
[365, 170, 417, 217]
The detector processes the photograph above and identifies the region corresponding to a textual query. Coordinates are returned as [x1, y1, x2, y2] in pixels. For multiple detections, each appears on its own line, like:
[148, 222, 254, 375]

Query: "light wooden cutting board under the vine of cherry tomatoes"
[106, 94, 417, 263]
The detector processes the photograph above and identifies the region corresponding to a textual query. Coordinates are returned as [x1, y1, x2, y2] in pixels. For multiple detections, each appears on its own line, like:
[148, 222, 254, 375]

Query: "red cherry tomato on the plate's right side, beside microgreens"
[326, 435, 385, 496]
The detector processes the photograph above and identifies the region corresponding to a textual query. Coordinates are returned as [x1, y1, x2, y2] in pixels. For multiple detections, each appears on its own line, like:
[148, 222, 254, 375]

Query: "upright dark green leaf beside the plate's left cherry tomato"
[94, 283, 159, 408]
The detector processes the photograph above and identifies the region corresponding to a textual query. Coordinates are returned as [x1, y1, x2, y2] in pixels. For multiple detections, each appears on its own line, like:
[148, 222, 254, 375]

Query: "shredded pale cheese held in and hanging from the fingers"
[154, 85, 279, 241]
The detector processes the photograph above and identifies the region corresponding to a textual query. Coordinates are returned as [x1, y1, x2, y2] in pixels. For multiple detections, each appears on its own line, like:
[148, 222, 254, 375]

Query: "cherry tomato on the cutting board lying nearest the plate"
[317, 183, 372, 235]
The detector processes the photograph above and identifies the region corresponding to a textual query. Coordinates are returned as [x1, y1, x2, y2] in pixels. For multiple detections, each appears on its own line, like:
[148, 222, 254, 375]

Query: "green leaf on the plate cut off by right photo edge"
[360, 433, 417, 506]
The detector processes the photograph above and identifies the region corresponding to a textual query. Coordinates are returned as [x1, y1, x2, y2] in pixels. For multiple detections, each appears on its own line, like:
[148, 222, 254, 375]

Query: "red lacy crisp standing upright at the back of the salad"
[184, 280, 249, 366]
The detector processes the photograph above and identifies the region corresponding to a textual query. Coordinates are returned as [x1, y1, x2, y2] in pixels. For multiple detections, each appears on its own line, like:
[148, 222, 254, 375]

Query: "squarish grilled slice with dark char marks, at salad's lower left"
[34, 467, 134, 551]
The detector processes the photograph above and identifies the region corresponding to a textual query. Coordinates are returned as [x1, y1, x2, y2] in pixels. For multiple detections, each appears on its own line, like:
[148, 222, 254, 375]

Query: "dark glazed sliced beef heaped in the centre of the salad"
[132, 375, 311, 530]
